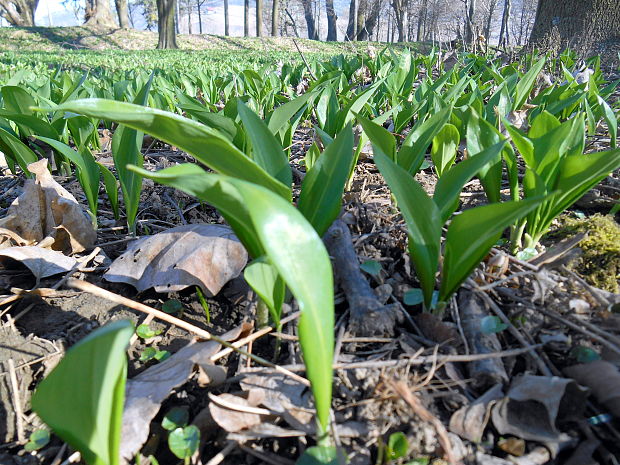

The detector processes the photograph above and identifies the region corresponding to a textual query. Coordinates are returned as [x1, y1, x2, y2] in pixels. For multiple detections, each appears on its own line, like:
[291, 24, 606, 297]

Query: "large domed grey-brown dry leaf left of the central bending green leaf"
[104, 224, 248, 296]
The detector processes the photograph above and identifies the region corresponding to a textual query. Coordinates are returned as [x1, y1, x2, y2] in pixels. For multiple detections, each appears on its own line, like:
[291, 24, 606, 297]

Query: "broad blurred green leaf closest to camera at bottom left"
[32, 320, 133, 465]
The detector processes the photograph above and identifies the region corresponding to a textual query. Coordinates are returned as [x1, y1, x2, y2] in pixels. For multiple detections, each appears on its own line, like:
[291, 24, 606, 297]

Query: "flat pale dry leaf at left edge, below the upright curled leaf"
[0, 246, 77, 279]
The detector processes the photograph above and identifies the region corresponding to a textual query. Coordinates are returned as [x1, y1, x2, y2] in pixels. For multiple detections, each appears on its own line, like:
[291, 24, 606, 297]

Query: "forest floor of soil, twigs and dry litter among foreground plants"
[0, 34, 620, 465]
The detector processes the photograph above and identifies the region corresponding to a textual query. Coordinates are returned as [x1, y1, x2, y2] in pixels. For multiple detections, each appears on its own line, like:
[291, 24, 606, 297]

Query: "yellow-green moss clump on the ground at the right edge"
[552, 214, 620, 293]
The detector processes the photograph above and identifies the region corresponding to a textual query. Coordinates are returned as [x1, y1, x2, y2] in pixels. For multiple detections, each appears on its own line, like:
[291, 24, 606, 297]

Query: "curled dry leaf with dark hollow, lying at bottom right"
[491, 375, 586, 451]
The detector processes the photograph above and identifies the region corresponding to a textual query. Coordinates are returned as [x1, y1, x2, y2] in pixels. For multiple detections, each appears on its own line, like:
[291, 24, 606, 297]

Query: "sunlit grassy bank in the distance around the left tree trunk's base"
[0, 27, 402, 70]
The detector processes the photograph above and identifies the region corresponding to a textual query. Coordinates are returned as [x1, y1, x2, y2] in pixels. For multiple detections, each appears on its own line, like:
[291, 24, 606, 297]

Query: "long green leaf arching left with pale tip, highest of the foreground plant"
[49, 99, 290, 200]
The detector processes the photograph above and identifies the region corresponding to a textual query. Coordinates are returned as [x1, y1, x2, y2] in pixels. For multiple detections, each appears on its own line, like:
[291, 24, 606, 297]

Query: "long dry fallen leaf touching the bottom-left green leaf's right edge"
[120, 324, 250, 460]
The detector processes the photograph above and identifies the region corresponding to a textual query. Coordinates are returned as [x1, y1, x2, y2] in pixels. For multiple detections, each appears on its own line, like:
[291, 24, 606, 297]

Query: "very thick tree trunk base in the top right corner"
[529, 0, 620, 55]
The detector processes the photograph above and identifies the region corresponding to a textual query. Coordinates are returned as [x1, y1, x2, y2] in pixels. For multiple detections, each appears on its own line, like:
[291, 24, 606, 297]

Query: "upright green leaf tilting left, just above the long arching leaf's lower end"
[237, 99, 293, 186]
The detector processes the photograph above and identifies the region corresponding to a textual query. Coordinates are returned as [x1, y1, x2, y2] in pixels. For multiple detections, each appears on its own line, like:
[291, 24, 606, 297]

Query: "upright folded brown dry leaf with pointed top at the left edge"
[0, 159, 97, 255]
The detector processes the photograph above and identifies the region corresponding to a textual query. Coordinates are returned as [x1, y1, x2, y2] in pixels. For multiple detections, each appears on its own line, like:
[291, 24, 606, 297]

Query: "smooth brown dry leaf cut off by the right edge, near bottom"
[564, 360, 620, 417]
